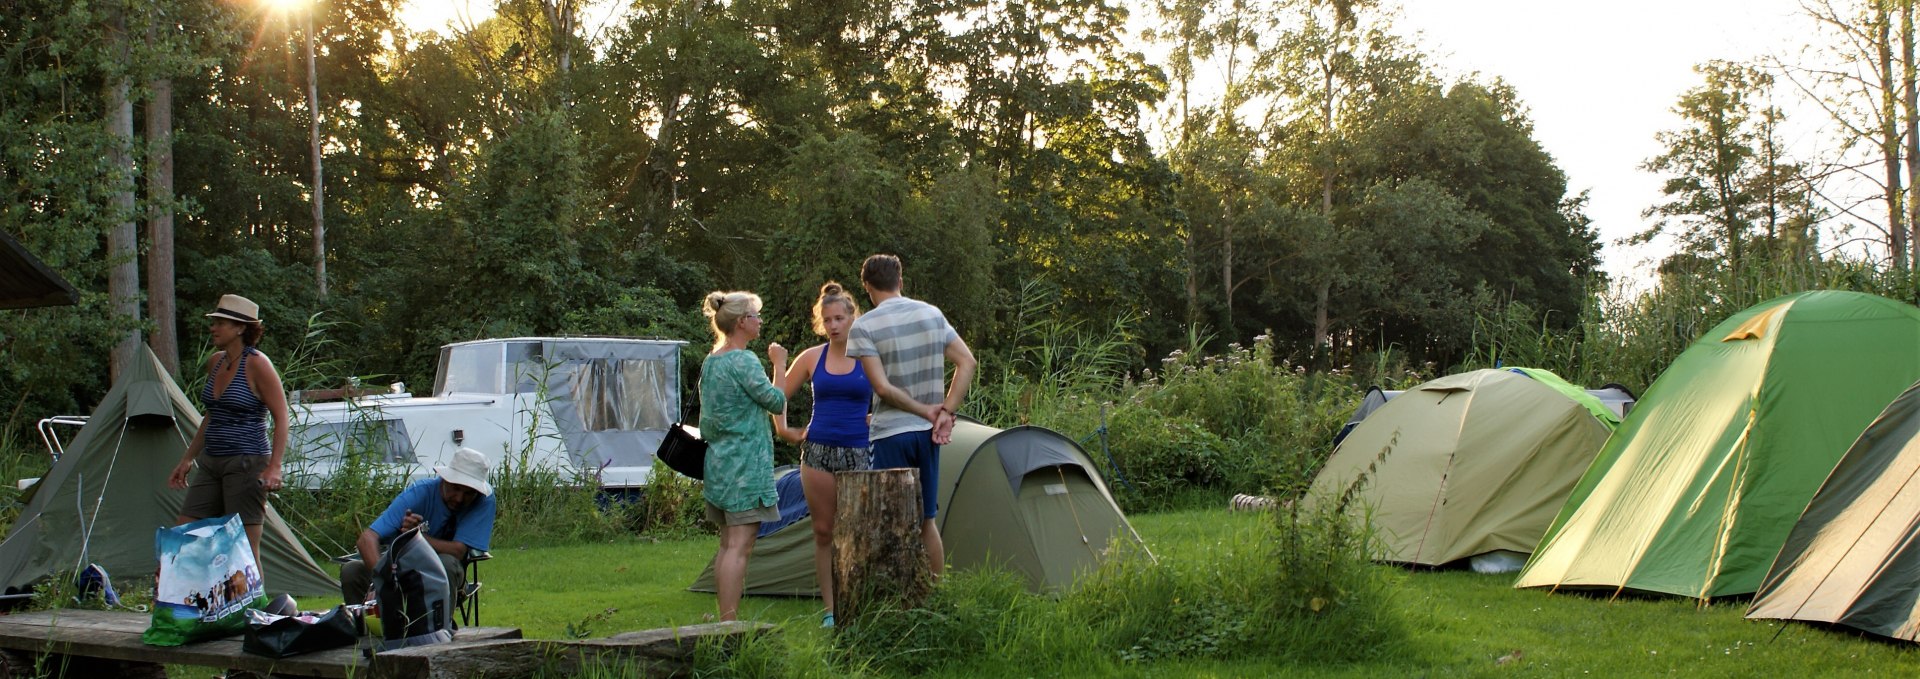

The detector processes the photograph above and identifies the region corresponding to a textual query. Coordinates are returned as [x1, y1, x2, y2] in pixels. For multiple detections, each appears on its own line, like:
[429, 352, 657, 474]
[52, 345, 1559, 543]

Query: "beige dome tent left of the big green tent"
[1308, 368, 1613, 570]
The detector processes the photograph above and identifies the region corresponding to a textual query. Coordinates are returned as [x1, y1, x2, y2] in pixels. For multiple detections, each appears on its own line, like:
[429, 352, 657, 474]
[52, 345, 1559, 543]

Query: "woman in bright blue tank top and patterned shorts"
[766, 280, 874, 627]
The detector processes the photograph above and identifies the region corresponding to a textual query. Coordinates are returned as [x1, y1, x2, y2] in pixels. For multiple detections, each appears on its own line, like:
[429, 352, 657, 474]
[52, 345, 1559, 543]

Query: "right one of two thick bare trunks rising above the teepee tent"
[146, 21, 180, 378]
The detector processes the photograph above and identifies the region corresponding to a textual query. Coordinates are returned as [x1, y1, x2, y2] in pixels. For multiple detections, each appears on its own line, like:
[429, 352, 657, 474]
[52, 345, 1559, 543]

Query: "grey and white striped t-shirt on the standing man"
[847, 297, 960, 439]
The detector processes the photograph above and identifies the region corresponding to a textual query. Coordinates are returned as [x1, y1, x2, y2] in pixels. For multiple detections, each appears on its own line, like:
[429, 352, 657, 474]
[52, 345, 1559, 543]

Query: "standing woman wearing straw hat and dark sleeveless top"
[167, 295, 286, 575]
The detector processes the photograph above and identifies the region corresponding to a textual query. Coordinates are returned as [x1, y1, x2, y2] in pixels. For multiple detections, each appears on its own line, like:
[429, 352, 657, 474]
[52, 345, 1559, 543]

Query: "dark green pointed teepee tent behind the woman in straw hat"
[0, 345, 340, 597]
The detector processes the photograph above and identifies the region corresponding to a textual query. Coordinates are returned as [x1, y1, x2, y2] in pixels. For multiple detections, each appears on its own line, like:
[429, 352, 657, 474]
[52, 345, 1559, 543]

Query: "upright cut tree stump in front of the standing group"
[833, 470, 933, 623]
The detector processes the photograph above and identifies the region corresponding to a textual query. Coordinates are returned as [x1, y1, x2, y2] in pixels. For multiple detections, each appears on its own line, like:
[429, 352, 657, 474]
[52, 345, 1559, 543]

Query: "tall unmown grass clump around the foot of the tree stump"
[701, 494, 1405, 677]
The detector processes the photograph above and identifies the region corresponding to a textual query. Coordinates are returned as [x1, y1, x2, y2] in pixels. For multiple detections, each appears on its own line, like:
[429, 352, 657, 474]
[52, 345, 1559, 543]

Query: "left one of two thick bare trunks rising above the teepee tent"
[102, 10, 140, 380]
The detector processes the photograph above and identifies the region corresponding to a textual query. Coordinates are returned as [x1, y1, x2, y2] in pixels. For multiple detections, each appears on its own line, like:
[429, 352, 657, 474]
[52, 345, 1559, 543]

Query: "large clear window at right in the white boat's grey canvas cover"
[568, 359, 674, 432]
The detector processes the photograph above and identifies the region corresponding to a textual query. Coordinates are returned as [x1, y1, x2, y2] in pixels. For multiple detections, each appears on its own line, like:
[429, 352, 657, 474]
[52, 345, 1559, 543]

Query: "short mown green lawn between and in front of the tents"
[468, 510, 1920, 677]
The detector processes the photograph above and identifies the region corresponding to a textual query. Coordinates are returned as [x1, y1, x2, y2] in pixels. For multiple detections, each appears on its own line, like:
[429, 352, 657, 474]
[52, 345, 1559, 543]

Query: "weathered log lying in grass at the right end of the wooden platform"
[372, 621, 774, 679]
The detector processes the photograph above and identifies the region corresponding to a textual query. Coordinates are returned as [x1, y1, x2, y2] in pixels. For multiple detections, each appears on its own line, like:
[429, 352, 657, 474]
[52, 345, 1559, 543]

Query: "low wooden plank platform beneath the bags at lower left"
[0, 610, 520, 677]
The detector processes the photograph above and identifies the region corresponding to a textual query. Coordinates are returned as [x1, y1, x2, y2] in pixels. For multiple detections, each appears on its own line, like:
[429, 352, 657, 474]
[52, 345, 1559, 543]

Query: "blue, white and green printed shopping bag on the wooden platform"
[140, 514, 267, 646]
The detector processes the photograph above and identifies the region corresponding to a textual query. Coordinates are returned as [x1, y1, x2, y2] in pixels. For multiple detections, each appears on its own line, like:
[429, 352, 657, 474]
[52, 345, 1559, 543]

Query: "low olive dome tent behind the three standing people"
[687, 420, 1140, 597]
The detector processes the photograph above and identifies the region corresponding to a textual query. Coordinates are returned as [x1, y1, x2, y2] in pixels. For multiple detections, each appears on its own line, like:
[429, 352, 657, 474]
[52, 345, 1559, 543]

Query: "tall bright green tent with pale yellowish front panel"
[1515, 292, 1920, 598]
